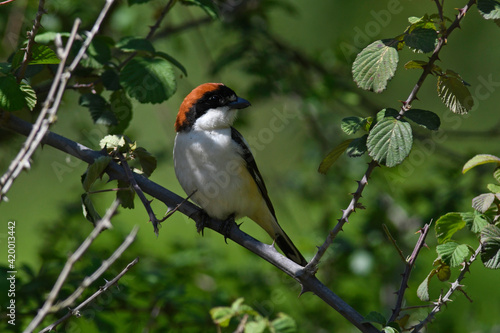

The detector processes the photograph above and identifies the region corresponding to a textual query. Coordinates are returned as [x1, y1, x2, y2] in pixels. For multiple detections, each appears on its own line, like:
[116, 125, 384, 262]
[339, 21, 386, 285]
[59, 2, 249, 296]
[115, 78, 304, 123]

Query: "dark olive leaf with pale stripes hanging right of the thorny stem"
[437, 69, 474, 114]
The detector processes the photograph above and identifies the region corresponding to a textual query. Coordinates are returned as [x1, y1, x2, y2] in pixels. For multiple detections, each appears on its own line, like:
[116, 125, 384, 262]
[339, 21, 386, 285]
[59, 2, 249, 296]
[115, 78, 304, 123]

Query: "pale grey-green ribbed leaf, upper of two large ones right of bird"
[352, 40, 399, 93]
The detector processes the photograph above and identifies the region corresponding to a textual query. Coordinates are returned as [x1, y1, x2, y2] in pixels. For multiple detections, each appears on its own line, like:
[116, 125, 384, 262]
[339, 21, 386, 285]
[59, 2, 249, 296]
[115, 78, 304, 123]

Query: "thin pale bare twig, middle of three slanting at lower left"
[50, 226, 139, 312]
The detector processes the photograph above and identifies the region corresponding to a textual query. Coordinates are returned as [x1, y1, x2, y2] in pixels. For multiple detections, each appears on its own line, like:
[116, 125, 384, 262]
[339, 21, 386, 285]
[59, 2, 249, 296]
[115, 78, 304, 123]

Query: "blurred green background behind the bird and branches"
[0, 0, 500, 332]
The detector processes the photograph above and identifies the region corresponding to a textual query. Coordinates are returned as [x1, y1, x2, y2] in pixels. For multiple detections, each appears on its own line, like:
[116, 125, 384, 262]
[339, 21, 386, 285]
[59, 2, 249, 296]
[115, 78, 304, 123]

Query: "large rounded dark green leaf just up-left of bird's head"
[120, 57, 177, 104]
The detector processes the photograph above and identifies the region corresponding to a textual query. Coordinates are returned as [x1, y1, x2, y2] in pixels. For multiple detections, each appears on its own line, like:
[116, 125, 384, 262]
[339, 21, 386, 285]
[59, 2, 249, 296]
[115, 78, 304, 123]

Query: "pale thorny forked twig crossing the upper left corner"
[0, 0, 114, 202]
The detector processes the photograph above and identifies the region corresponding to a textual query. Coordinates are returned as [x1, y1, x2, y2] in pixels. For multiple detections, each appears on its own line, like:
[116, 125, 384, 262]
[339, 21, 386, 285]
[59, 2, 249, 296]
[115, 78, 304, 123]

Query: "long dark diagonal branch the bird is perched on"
[0, 116, 378, 332]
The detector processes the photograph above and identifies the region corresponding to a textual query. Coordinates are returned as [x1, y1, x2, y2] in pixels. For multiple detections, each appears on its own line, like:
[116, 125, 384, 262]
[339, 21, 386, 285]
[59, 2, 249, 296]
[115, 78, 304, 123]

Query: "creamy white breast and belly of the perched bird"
[174, 128, 262, 220]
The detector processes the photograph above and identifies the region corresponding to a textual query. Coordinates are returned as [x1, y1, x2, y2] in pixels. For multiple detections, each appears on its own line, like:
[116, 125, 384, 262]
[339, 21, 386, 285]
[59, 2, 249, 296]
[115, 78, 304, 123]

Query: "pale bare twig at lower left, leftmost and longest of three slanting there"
[24, 200, 119, 333]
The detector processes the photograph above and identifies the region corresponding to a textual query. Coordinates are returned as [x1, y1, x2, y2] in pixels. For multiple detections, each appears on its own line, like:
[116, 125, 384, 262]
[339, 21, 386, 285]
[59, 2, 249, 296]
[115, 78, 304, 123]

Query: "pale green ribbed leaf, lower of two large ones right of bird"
[366, 117, 413, 167]
